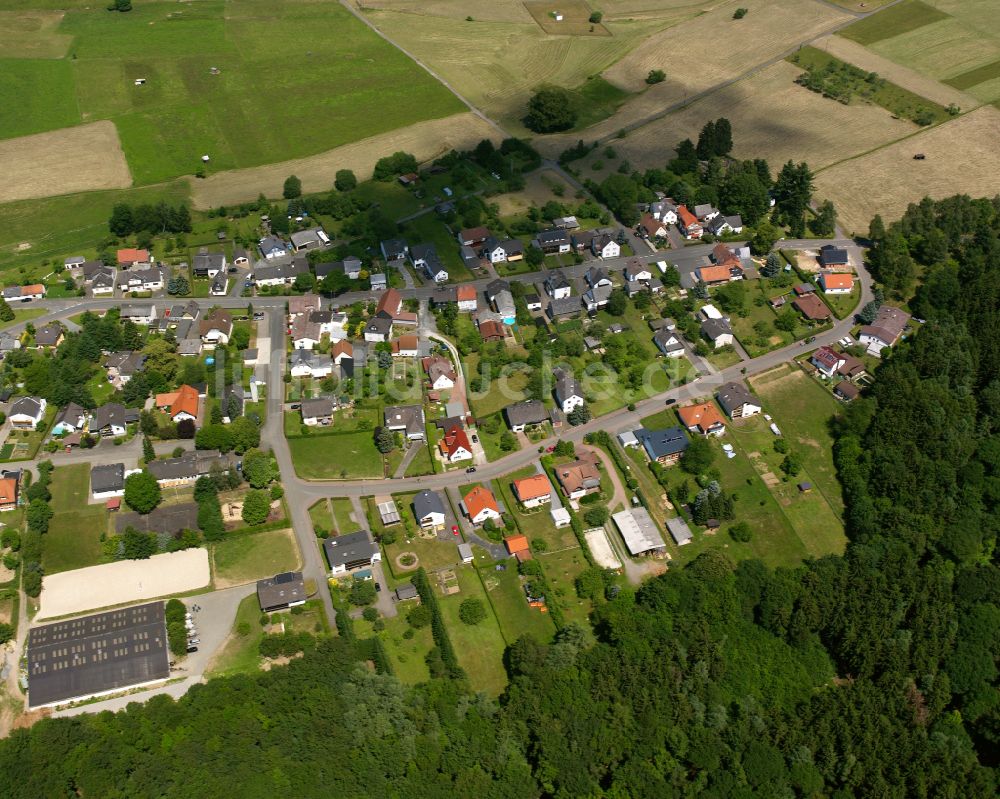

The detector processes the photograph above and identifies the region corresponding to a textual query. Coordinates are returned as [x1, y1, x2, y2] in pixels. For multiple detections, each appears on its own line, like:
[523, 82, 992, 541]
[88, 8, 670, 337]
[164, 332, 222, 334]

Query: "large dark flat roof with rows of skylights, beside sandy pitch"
[28, 602, 170, 707]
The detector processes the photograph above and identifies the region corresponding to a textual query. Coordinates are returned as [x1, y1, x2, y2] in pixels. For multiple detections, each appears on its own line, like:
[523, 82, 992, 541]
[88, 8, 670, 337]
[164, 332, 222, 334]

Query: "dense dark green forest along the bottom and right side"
[0, 198, 1000, 799]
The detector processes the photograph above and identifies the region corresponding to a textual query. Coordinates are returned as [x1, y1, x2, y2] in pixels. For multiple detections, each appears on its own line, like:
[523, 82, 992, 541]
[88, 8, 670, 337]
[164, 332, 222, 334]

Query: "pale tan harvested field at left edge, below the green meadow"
[0, 122, 132, 203]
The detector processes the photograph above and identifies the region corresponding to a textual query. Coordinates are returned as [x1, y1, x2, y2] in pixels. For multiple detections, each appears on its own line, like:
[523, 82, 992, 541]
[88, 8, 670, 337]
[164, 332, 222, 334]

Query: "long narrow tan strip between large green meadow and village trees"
[191, 113, 499, 208]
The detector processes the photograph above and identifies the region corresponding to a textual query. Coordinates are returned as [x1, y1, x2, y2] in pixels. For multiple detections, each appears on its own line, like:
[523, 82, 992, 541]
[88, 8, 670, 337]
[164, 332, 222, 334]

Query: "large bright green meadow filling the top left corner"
[0, 0, 462, 192]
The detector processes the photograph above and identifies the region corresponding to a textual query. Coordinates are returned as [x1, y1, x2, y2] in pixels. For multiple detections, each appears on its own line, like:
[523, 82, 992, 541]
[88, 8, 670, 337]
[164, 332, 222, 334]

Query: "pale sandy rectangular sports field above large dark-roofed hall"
[35, 548, 211, 621]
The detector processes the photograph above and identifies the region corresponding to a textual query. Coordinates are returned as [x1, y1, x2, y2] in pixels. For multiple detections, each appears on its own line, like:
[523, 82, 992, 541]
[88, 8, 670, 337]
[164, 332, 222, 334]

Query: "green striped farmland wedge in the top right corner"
[840, 0, 1000, 103]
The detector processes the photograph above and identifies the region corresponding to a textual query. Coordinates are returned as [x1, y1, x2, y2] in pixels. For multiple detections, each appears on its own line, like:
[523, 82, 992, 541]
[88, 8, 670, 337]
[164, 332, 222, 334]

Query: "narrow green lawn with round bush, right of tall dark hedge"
[442, 566, 512, 696]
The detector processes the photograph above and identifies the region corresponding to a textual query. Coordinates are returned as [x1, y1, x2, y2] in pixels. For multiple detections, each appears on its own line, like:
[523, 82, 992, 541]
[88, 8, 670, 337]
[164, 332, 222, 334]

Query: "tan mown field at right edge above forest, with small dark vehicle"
[816, 106, 1000, 231]
